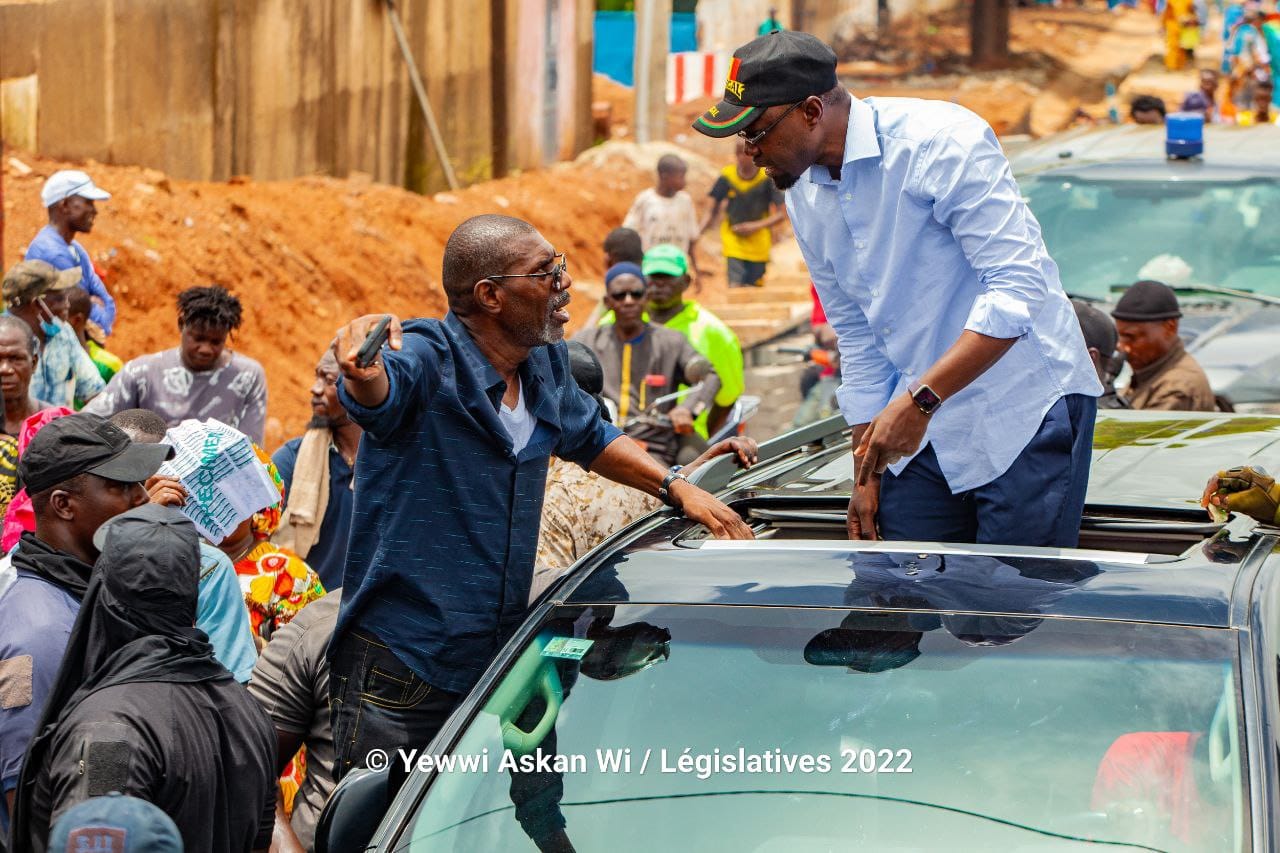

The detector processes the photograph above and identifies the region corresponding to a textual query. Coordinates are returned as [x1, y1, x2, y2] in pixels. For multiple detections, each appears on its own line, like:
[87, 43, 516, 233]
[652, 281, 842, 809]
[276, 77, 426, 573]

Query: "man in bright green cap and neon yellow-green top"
[624, 243, 746, 438]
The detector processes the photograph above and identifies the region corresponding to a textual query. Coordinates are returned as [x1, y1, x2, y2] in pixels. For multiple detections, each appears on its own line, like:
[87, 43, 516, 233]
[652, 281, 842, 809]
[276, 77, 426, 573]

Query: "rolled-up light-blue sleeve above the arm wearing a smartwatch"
[909, 119, 1050, 339]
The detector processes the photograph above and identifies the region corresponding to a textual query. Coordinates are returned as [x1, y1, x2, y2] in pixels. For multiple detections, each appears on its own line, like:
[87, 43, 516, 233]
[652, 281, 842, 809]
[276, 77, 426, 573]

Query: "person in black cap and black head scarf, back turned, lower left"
[12, 502, 275, 853]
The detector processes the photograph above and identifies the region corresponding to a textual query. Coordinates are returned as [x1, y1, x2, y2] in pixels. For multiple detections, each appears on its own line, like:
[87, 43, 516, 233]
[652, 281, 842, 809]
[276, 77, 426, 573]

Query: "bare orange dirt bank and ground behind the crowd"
[3, 0, 1158, 448]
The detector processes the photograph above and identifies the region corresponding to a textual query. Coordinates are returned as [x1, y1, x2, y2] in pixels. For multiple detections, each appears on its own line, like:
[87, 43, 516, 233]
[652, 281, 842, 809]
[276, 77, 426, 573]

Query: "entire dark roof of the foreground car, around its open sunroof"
[553, 411, 1280, 628]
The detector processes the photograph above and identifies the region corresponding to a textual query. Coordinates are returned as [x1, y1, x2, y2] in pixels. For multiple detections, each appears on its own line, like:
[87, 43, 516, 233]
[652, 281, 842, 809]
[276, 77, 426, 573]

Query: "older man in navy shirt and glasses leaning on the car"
[329, 215, 751, 809]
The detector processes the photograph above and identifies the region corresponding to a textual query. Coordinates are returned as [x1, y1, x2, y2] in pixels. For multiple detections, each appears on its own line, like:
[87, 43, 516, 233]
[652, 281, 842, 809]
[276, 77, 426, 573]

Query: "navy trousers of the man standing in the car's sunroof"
[877, 394, 1098, 548]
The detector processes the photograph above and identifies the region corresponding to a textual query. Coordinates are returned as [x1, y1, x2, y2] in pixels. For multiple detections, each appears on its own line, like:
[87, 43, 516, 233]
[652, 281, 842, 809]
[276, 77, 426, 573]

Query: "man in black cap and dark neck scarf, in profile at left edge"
[0, 414, 173, 830]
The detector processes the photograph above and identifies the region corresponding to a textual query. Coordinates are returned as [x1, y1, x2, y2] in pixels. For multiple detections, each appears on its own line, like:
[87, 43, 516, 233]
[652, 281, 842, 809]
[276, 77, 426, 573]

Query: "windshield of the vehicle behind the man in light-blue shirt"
[1019, 175, 1280, 298]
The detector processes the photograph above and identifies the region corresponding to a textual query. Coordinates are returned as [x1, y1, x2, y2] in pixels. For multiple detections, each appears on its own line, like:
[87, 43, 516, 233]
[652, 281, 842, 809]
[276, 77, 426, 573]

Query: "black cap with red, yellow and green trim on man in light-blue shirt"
[694, 29, 840, 138]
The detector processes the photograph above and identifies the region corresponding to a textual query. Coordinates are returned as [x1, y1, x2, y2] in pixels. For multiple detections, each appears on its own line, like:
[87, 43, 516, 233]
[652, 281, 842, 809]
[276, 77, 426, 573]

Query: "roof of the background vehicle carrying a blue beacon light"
[1010, 124, 1280, 181]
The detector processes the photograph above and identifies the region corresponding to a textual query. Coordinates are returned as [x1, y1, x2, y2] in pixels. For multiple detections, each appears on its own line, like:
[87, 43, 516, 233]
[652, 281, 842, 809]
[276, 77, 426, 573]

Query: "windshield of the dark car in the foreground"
[394, 605, 1247, 853]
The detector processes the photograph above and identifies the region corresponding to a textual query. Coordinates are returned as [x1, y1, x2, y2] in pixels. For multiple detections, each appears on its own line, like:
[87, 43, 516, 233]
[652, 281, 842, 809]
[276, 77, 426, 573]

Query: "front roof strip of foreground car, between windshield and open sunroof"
[564, 535, 1243, 628]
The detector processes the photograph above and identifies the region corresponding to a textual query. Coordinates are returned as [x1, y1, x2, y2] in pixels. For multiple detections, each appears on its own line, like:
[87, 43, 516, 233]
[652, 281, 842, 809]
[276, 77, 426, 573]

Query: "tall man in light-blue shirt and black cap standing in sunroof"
[694, 32, 1102, 547]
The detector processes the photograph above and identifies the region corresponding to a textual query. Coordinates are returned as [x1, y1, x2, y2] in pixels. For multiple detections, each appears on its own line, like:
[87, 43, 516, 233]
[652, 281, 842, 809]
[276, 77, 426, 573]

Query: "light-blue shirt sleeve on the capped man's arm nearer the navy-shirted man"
[796, 225, 897, 425]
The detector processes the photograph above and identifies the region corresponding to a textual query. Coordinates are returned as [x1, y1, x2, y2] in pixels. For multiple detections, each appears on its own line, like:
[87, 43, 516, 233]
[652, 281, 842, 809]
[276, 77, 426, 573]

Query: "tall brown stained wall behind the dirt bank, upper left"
[0, 0, 591, 191]
